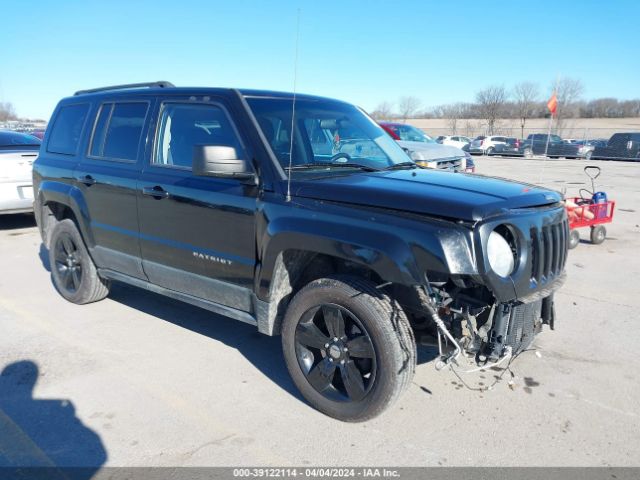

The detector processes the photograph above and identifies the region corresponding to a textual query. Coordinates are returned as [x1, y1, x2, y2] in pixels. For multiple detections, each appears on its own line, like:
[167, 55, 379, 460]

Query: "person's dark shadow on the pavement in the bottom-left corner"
[0, 360, 107, 479]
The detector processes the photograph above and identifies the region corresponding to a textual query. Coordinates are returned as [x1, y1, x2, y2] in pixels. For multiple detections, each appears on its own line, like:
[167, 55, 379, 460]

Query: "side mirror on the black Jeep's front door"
[192, 145, 254, 180]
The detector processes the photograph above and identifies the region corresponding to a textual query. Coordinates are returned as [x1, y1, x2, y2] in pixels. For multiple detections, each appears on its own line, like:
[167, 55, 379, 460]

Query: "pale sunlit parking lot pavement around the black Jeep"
[0, 157, 640, 466]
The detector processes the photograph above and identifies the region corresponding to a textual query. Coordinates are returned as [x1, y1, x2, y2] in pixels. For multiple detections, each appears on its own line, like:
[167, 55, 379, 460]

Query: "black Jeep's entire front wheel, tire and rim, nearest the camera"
[282, 276, 416, 422]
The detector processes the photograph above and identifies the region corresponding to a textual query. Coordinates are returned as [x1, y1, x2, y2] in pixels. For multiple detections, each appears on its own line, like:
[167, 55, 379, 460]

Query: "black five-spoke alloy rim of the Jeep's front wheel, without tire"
[295, 304, 376, 402]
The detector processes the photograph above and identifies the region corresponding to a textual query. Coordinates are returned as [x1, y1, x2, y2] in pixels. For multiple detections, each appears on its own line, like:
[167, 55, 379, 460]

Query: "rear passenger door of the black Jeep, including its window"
[75, 98, 152, 279]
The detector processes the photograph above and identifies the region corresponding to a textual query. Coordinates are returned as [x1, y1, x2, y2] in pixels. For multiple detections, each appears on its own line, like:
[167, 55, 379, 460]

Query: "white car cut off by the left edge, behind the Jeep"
[0, 130, 40, 214]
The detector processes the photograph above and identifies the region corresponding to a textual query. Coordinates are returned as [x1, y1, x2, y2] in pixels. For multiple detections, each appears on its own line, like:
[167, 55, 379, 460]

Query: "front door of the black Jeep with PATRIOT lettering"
[138, 97, 257, 312]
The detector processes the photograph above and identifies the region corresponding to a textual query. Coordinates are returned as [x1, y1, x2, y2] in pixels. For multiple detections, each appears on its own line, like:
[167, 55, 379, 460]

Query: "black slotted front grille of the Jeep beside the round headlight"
[531, 219, 569, 285]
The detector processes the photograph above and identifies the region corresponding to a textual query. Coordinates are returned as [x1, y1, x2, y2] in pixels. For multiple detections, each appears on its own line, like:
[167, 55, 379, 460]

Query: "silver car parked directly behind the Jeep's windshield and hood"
[380, 122, 467, 172]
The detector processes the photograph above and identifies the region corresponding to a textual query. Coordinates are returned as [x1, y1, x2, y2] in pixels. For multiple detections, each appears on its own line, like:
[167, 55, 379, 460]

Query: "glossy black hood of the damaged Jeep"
[291, 169, 562, 221]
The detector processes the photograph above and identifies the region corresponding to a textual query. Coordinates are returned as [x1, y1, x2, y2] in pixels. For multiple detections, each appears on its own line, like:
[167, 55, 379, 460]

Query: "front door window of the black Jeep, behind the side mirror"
[153, 103, 241, 168]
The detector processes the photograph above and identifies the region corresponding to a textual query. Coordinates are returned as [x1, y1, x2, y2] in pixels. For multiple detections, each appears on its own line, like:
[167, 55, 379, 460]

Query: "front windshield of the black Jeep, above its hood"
[247, 97, 411, 171]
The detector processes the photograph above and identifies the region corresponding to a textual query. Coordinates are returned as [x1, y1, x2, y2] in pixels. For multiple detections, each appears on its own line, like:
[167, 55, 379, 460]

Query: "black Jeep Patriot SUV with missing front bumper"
[33, 82, 568, 421]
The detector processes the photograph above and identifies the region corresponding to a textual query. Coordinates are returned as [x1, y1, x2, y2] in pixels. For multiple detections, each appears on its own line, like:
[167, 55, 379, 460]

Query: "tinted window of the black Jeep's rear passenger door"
[89, 102, 149, 161]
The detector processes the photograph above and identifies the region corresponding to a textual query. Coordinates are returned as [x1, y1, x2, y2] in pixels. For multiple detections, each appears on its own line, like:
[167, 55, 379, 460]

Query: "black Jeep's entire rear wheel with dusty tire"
[49, 218, 110, 305]
